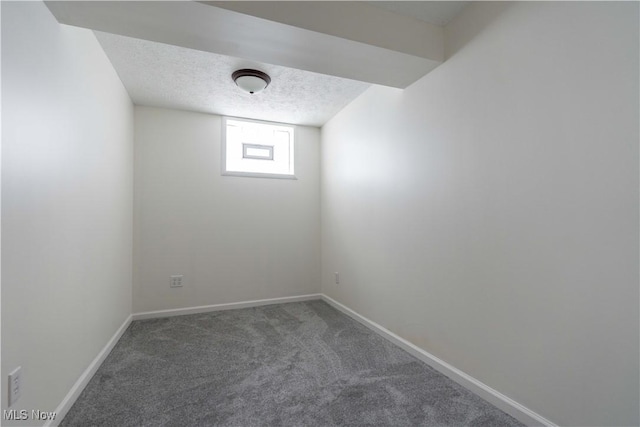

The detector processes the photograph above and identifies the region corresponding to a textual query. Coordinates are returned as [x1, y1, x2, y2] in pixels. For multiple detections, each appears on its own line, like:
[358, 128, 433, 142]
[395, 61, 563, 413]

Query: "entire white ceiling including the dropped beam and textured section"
[46, 1, 468, 126]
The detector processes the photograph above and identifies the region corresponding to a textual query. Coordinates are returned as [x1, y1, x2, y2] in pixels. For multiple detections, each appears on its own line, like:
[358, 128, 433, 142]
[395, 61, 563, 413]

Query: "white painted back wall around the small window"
[133, 107, 320, 313]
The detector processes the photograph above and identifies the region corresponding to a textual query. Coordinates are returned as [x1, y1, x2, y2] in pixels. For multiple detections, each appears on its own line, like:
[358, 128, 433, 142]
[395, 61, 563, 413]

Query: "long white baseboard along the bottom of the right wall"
[322, 294, 557, 427]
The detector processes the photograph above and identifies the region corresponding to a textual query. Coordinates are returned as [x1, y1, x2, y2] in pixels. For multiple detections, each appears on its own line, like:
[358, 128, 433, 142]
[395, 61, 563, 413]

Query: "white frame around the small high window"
[220, 117, 297, 180]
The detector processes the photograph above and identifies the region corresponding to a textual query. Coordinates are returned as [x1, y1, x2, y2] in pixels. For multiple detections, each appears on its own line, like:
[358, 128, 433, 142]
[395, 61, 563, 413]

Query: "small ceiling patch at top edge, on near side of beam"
[367, 1, 469, 26]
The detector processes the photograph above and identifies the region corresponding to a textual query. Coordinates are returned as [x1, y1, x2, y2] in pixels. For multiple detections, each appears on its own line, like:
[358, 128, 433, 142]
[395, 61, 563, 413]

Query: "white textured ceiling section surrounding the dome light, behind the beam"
[95, 31, 369, 126]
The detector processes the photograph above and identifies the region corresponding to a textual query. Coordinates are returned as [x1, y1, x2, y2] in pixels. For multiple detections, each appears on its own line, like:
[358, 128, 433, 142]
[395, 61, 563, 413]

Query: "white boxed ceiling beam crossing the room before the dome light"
[46, 1, 443, 88]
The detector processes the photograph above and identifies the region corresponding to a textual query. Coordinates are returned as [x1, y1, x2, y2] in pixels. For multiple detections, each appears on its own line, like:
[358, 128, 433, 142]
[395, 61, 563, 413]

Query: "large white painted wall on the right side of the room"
[321, 2, 640, 426]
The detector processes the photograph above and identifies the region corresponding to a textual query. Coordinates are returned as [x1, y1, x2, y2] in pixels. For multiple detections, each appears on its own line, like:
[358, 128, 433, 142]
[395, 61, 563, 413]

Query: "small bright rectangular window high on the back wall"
[222, 118, 295, 179]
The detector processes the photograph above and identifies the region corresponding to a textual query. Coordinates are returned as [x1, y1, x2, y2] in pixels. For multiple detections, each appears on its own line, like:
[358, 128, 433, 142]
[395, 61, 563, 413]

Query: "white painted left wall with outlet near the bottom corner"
[1, 2, 133, 425]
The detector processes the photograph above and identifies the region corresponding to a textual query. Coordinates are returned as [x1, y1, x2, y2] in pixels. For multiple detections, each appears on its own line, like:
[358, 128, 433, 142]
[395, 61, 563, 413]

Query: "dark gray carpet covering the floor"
[61, 301, 522, 427]
